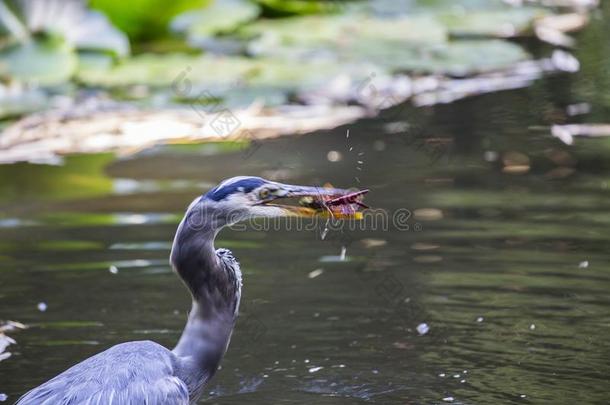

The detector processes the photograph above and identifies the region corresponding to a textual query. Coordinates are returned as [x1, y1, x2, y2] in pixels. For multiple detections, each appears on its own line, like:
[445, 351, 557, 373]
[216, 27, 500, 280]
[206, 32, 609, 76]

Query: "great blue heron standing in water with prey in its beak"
[17, 177, 360, 405]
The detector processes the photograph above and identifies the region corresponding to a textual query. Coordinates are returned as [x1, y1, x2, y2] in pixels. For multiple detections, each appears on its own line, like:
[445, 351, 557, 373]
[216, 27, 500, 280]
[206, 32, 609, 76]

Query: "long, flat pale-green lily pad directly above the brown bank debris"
[78, 54, 379, 96]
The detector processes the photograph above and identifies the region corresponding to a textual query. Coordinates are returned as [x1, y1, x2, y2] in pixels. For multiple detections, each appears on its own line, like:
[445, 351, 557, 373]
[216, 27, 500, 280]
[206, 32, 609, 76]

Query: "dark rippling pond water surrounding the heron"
[0, 6, 610, 404]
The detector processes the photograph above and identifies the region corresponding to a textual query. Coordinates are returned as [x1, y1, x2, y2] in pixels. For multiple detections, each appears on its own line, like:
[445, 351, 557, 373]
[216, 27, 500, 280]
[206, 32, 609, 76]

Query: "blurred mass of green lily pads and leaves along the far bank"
[0, 0, 588, 126]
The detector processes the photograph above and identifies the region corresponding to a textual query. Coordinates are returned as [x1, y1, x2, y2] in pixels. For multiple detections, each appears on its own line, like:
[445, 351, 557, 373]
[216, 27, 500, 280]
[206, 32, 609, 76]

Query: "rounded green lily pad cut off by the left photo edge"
[0, 41, 78, 85]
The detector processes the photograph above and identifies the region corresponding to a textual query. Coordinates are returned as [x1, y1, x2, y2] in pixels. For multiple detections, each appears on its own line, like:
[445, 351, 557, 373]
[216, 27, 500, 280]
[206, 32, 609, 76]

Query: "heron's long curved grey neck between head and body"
[171, 211, 240, 386]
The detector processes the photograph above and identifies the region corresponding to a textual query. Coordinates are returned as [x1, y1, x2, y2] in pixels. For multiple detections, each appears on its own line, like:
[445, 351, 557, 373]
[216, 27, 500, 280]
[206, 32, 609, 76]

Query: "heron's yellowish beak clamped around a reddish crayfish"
[263, 184, 368, 219]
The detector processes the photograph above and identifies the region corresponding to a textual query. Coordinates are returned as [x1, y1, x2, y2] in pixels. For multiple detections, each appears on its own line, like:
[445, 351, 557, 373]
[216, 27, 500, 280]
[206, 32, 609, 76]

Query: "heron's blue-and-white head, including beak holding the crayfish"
[193, 176, 364, 229]
